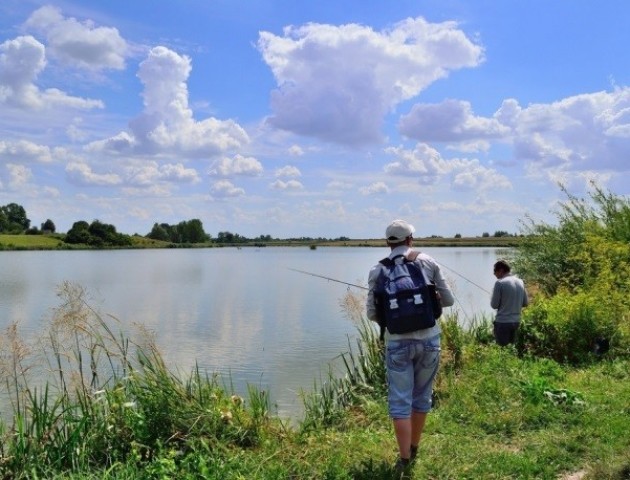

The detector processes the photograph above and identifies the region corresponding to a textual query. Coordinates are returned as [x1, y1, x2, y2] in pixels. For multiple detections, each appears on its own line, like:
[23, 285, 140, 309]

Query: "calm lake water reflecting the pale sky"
[0, 247, 501, 417]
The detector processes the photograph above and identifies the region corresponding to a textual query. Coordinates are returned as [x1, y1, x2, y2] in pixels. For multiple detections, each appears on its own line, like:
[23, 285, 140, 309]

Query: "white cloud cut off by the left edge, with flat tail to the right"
[0, 36, 103, 109]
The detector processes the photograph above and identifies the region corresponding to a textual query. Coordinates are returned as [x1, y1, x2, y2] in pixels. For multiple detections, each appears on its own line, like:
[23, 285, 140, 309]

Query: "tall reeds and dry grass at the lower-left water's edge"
[0, 283, 274, 478]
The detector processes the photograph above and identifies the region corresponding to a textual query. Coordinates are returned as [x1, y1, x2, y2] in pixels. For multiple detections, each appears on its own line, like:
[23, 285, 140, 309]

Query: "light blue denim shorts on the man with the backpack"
[385, 335, 440, 418]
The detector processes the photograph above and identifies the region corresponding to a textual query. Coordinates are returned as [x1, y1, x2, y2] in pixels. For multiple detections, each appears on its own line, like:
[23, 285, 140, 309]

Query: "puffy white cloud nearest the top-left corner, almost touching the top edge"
[24, 5, 129, 70]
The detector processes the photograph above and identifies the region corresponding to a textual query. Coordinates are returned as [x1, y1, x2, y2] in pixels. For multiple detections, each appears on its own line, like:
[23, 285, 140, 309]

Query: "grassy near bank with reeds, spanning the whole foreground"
[0, 284, 630, 480]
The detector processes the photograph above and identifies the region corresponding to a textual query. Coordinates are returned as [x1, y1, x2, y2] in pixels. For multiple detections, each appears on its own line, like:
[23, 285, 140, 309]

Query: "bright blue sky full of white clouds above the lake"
[0, 0, 630, 238]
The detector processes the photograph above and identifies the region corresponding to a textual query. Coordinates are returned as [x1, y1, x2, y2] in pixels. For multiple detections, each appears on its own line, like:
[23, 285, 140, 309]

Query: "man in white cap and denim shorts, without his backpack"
[366, 220, 455, 469]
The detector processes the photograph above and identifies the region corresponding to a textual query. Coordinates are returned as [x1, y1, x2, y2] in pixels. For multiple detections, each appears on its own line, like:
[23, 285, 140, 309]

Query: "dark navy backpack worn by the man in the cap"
[374, 252, 442, 333]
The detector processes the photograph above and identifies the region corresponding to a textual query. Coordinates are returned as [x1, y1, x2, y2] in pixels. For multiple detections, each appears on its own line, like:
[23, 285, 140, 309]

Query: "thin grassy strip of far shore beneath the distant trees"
[0, 234, 522, 250]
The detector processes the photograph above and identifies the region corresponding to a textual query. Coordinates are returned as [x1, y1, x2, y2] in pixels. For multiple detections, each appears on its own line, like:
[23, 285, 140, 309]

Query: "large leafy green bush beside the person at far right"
[513, 187, 630, 364]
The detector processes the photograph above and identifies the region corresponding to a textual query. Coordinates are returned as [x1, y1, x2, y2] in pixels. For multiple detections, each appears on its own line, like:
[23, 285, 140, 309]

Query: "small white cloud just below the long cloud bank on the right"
[384, 143, 512, 191]
